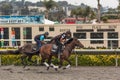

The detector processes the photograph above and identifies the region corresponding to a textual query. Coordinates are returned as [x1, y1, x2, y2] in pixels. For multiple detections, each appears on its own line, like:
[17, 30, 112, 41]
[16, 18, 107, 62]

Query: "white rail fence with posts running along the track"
[0, 39, 120, 67]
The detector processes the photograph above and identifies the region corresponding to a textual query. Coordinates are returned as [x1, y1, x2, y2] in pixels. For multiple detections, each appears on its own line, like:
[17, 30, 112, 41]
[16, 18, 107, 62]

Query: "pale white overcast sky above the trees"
[23, 0, 118, 8]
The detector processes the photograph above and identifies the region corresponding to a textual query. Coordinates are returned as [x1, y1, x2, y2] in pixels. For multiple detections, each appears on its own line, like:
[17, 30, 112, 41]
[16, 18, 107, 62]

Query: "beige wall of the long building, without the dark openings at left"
[0, 23, 120, 48]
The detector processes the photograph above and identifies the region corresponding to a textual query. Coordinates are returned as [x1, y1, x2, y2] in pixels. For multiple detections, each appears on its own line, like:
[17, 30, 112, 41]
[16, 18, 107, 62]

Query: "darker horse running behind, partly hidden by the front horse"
[0, 42, 45, 68]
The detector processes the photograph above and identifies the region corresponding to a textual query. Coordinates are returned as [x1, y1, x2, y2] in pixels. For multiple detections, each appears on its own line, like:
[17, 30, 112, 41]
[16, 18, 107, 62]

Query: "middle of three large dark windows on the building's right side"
[90, 33, 104, 44]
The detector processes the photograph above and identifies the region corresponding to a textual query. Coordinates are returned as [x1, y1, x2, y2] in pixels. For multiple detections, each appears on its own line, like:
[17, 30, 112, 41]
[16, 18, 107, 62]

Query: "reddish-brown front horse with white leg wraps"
[39, 38, 84, 69]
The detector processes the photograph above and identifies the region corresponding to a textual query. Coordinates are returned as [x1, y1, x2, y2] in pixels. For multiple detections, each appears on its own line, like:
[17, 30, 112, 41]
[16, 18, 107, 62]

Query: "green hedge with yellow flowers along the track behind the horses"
[2, 55, 120, 66]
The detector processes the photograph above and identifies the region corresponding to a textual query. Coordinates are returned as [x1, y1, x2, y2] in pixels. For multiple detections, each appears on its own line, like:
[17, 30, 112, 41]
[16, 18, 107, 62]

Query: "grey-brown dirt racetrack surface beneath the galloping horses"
[0, 66, 120, 80]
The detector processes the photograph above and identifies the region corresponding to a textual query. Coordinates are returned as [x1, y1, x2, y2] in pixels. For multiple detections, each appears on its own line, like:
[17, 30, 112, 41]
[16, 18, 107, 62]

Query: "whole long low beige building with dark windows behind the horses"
[0, 15, 120, 48]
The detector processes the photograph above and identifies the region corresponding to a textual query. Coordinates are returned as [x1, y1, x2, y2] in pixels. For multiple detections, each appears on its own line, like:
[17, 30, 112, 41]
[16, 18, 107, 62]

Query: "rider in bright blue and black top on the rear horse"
[34, 32, 49, 48]
